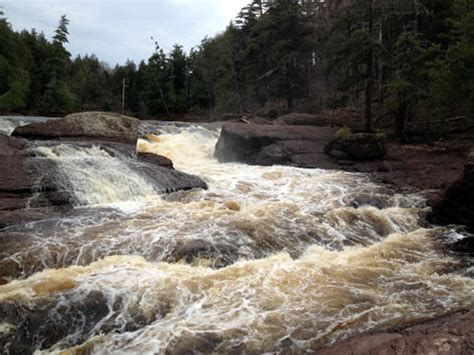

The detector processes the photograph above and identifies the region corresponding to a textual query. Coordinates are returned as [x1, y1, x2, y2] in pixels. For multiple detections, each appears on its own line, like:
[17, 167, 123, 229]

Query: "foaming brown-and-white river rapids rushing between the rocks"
[0, 126, 474, 354]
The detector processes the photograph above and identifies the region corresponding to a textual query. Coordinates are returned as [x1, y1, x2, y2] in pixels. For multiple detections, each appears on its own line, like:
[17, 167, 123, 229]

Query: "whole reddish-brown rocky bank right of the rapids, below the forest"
[216, 123, 474, 198]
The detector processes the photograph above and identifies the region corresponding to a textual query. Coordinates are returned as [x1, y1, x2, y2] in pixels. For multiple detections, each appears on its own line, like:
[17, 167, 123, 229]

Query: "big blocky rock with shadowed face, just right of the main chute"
[215, 123, 337, 168]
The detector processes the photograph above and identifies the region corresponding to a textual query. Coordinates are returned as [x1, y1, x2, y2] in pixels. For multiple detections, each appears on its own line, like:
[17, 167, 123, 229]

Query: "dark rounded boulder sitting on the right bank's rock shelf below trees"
[324, 133, 387, 161]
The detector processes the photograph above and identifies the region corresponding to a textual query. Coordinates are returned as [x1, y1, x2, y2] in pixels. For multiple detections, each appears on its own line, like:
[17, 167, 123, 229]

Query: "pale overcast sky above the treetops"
[4, 0, 250, 65]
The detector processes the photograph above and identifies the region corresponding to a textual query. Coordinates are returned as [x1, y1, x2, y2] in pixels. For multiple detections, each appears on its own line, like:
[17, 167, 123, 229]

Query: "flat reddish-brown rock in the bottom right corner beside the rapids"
[317, 311, 474, 355]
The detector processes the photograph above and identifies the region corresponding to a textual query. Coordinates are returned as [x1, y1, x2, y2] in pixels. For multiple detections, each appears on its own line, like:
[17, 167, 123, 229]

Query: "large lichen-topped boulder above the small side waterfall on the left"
[12, 112, 139, 145]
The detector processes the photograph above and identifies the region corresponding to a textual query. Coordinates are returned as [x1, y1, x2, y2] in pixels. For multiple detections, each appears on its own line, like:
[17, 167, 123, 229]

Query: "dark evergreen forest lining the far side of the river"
[0, 0, 474, 137]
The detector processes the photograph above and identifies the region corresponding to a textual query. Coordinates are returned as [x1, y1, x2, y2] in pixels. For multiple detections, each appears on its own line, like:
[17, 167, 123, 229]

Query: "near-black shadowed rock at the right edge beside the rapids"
[430, 150, 474, 232]
